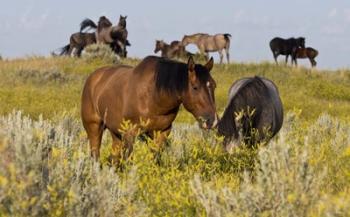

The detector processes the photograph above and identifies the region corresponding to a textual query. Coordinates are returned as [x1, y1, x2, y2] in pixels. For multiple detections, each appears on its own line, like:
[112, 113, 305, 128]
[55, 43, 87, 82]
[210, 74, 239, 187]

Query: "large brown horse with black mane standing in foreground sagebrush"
[81, 56, 217, 162]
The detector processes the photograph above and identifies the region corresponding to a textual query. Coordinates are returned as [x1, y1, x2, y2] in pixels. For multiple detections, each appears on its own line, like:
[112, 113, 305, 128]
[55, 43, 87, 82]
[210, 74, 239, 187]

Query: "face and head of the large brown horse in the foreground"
[182, 57, 218, 129]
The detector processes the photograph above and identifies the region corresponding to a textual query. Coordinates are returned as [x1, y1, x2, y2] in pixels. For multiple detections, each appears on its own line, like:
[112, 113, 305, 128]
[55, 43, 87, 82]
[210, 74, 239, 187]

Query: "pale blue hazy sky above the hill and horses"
[0, 0, 350, 69]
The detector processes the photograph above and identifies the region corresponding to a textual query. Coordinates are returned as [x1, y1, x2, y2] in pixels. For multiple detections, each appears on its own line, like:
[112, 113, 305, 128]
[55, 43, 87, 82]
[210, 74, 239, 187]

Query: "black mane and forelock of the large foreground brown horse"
[152, 57, 210, 94]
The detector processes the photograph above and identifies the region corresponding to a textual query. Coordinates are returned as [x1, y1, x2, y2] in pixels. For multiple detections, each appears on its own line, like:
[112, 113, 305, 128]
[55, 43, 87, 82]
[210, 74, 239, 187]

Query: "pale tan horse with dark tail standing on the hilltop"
[182, 33, 231, 63]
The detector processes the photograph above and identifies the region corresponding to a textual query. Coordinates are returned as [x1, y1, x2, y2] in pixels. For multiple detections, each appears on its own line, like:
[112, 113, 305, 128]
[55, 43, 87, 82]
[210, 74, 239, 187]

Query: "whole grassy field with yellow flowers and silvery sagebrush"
[0, 57, 350, 216]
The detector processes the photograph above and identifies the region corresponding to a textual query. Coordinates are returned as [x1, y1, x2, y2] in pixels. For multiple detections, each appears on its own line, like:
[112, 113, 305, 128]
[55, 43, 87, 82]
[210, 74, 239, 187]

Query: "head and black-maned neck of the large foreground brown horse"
[155, 57, 218, 129]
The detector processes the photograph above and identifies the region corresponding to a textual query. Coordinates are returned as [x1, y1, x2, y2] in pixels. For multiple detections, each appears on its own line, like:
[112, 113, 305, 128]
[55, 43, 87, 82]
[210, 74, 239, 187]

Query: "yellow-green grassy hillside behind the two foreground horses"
[0, 55, 350, 122]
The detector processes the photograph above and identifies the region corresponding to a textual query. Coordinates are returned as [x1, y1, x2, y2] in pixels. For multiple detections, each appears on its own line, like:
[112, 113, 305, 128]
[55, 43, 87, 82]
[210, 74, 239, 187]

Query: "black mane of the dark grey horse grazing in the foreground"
[218, 76, 268, 141]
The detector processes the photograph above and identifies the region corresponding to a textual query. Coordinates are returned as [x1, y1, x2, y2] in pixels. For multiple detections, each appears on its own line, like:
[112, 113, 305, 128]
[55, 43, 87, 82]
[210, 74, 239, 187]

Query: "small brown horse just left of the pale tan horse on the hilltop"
[154, 40, 189, 59]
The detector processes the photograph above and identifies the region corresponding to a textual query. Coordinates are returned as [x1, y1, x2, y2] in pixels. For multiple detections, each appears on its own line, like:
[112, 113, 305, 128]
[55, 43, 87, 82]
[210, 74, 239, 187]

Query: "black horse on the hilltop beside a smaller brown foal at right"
[270, 37, 305, 64]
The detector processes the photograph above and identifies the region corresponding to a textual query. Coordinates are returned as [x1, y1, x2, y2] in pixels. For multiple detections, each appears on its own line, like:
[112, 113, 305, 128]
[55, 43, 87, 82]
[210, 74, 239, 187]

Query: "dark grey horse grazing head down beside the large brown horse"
[218, 76, 283, 151]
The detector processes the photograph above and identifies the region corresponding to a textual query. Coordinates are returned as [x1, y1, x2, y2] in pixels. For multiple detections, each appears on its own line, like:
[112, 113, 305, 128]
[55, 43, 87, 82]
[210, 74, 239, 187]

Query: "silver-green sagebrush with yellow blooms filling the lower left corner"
[0, 112, 145, 216]
